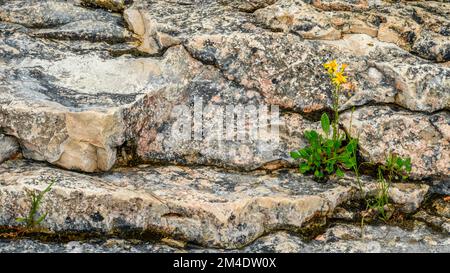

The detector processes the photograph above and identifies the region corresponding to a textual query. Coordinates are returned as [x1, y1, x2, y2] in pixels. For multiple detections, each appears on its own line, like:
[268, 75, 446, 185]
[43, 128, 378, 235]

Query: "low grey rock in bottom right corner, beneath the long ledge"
[243, 223, 450, 253]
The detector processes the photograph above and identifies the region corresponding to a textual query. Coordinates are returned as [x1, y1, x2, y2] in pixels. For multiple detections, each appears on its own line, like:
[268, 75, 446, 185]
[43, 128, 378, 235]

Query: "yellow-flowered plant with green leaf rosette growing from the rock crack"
[290, 60, 358, 179]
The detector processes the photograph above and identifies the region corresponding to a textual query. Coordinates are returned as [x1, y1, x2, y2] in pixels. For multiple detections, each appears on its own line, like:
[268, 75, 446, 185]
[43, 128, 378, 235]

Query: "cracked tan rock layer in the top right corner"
[255, 0, 450, 62]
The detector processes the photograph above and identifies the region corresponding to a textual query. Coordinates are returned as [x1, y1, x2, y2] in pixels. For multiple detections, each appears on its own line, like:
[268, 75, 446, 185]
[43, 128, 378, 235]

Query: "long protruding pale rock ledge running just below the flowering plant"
[0, 160, 434, 248]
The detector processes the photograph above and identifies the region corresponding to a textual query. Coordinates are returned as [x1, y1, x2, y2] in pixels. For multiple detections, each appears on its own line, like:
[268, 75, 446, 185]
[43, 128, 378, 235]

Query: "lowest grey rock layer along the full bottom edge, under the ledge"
[0, 223, 450, 253]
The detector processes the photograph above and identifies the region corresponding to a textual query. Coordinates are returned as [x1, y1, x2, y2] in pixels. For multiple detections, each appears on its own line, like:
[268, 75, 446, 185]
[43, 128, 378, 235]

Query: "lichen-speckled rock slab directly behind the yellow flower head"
[186, 33, 450, 114]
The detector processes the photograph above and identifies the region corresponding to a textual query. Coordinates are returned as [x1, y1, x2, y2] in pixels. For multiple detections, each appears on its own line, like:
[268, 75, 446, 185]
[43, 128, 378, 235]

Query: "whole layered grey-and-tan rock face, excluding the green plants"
[0, 0, 450, 252]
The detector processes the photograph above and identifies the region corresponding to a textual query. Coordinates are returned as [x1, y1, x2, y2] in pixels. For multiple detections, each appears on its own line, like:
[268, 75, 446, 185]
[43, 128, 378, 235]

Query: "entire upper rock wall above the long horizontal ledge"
[0, 0, 450, 177]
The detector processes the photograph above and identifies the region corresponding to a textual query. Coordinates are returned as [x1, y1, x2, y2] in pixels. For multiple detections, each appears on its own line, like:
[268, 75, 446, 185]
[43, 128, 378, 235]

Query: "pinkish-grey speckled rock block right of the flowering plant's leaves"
[341, 106, 450, 178]
